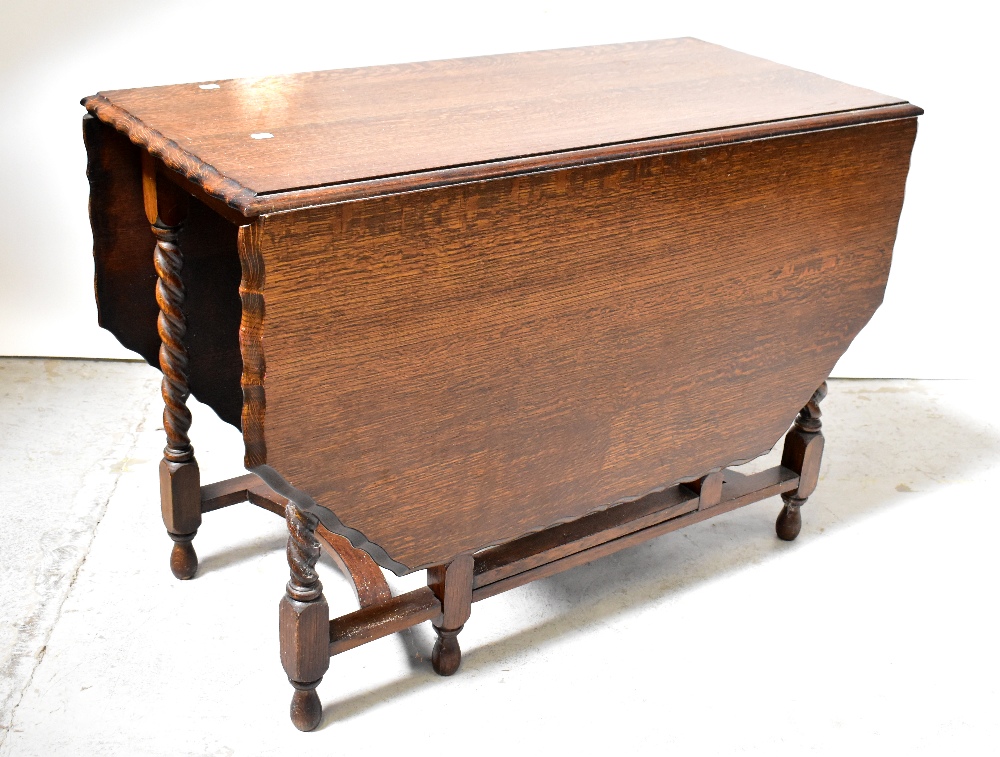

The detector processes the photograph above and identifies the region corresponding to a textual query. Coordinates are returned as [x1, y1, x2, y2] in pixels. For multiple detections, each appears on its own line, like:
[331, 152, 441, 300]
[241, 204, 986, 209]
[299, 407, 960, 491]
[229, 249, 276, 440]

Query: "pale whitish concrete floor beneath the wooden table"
[0, 359, 1000, 757]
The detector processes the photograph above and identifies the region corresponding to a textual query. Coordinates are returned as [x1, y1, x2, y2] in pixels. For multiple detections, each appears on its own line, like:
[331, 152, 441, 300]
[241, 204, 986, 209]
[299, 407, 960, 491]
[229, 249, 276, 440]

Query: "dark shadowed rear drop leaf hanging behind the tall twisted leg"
[83, 116, 243, 428]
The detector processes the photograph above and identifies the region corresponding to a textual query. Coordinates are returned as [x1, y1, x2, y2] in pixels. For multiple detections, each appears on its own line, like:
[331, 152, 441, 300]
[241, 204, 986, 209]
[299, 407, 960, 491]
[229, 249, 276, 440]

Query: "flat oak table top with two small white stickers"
[83, 39, 919, 214]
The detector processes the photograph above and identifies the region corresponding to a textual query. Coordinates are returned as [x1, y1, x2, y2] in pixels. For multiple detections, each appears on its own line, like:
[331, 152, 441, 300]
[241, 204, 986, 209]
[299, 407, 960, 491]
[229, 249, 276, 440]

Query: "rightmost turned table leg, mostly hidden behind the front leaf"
[775, 381, 827, 541]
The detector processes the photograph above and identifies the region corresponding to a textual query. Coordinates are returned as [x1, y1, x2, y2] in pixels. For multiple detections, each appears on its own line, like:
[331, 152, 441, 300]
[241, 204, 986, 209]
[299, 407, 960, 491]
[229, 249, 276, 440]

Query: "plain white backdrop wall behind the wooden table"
[0, 0, 1000, 378]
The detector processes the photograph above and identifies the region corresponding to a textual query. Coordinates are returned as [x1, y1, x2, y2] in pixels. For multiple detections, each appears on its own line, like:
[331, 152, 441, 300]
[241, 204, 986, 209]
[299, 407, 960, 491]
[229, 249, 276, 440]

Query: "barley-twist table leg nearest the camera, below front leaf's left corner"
[278, 502, 330, 731]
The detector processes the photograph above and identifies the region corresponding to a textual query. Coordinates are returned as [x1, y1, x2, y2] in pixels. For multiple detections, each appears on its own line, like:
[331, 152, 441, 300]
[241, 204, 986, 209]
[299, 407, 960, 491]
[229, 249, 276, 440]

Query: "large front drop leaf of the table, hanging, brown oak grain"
[244, 118, 916, 570]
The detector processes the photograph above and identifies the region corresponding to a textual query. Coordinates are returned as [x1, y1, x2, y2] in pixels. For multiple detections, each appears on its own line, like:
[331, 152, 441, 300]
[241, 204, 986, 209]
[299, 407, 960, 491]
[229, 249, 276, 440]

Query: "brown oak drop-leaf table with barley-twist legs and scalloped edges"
[83, 39, 922, 730]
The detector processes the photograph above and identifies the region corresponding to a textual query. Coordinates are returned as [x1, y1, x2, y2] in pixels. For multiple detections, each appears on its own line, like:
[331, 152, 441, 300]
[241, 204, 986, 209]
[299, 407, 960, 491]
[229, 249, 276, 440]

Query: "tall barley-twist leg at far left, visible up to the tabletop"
[142, 155, 201, 579]
